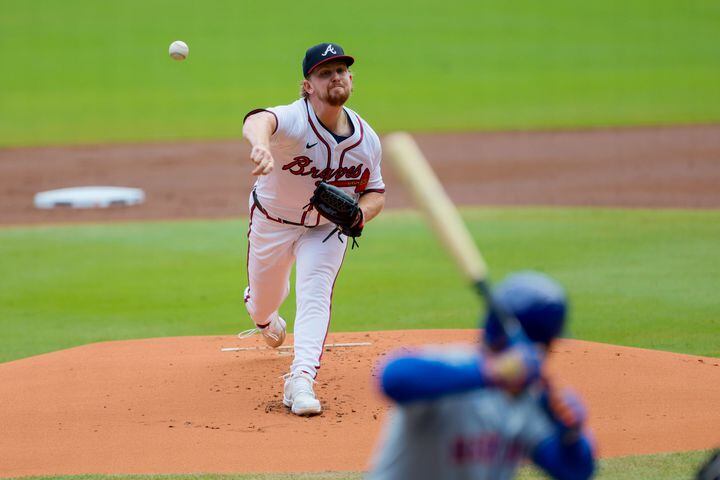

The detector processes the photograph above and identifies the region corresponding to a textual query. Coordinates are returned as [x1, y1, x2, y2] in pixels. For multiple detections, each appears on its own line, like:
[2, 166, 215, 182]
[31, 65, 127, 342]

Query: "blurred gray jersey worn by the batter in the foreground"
[366, 388, 554, 480]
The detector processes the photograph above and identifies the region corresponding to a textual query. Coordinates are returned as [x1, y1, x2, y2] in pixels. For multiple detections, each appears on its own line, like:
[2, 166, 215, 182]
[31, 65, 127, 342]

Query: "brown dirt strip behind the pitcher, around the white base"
[0, 125, 720, 225]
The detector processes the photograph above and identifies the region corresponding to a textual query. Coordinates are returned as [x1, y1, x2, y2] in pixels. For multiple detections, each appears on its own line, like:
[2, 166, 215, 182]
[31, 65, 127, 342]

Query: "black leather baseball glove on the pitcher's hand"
[310, 182, 365, 248]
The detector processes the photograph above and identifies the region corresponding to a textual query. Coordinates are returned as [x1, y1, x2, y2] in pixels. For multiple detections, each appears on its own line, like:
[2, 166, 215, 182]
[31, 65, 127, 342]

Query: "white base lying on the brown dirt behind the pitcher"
[35, 187, 145, 209]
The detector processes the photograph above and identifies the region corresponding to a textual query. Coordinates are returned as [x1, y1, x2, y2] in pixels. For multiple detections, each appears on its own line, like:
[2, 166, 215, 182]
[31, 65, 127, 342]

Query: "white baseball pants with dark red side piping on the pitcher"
[245, 199, 347, 377]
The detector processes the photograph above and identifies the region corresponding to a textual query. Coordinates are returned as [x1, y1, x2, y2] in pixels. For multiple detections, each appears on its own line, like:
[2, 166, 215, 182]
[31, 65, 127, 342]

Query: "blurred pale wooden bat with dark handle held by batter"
[383, 132, 524, 339]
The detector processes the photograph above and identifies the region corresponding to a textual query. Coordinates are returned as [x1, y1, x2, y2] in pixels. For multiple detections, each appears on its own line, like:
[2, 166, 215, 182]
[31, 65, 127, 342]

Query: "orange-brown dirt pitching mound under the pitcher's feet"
[0, 330, 720, 477]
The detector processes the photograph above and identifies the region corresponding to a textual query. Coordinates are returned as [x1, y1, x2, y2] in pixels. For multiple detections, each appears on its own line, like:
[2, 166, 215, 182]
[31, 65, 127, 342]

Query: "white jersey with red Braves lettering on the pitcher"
[246, 99, 385, 226]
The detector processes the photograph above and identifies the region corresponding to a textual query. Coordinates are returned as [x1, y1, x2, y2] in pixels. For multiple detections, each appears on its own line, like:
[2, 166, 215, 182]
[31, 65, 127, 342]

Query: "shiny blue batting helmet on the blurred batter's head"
[485, 271, 567, 346]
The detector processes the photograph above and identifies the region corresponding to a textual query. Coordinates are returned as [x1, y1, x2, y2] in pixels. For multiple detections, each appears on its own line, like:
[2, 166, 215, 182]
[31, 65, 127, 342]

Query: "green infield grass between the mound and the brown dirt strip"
[0, 208, 720, 361]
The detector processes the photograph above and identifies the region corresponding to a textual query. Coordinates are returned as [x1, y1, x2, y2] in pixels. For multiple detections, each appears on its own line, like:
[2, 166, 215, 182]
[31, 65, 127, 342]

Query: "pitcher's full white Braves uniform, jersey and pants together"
[245, 99, 385, 377]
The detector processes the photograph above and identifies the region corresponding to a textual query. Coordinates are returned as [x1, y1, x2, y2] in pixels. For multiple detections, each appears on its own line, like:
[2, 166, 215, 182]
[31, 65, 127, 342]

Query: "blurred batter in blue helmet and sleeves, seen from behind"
[368, 272, 594, 480]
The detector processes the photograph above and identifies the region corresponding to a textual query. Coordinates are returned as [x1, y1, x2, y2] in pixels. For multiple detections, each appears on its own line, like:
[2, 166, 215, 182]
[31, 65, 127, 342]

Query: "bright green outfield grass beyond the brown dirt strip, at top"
[0, 0, 720, 146]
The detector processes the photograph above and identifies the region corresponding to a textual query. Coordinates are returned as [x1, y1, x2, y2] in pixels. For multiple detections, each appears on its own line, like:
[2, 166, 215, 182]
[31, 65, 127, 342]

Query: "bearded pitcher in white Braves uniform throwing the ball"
[241, 43, 385, 415]
